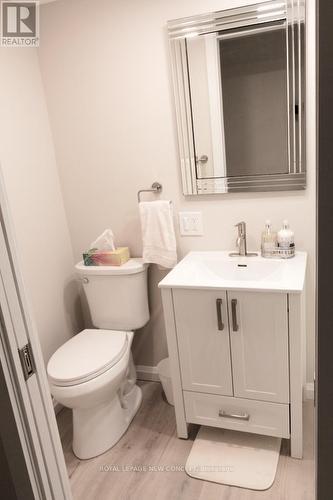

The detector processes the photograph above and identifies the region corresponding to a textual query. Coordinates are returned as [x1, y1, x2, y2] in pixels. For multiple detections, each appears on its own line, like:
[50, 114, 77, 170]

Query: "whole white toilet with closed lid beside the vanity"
[47, 259, 149, 459]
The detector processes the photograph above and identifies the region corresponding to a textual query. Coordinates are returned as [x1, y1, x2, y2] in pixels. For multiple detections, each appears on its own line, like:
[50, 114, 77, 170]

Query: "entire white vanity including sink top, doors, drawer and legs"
[159, 252, 306, 458]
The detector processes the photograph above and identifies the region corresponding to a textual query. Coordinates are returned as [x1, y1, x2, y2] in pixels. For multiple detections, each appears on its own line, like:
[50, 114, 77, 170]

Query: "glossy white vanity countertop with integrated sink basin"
[159, 252, 306, 292]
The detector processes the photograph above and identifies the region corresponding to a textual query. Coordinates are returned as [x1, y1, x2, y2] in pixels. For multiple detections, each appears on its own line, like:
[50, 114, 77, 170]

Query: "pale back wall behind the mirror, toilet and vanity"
[39, 0, 315, 380]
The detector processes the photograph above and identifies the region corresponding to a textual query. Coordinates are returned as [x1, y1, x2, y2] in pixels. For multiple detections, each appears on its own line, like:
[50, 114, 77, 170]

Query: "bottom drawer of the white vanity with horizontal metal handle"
[183, 391, 290, 438]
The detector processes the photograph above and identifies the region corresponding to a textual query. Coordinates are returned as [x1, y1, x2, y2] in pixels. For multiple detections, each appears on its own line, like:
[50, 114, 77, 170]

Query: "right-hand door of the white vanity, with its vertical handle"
[228, 292, 289, 403]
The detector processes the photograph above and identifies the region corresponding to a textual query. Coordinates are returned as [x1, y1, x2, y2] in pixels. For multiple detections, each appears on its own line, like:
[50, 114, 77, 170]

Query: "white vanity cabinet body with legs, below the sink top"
[162, 280, 304, 458]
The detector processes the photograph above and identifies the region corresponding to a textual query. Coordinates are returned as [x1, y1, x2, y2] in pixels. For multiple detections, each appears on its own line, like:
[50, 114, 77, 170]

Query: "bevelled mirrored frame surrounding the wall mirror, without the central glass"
[168, 0, 306, 195]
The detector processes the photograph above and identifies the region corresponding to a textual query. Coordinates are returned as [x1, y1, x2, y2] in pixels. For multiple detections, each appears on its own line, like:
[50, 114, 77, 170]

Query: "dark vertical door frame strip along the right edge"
[315, 0, 333, 500]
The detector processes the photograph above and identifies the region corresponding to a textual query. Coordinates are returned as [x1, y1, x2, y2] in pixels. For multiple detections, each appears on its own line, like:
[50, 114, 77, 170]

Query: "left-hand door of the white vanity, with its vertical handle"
[173, 290, 233, 396]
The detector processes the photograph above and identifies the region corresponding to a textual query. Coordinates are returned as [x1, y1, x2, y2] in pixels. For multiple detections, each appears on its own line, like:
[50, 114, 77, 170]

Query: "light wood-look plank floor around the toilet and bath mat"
[58, 382, 314, 500]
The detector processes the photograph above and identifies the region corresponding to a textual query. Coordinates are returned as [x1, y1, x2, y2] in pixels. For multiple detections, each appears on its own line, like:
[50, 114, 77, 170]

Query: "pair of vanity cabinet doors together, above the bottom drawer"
[173, 289, 289, 404]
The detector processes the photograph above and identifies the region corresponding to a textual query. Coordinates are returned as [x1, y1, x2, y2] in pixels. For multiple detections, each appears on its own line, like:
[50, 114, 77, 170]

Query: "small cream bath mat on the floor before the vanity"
[185, 426, 281, 490]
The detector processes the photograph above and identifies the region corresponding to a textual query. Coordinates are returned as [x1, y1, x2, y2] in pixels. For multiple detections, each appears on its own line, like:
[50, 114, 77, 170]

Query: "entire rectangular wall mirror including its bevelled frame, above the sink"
[168, 1, 306, 194]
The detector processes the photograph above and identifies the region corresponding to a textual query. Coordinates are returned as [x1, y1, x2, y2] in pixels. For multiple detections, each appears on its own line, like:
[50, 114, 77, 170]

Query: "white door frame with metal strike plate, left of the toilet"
[0, 166, 72, 500]
